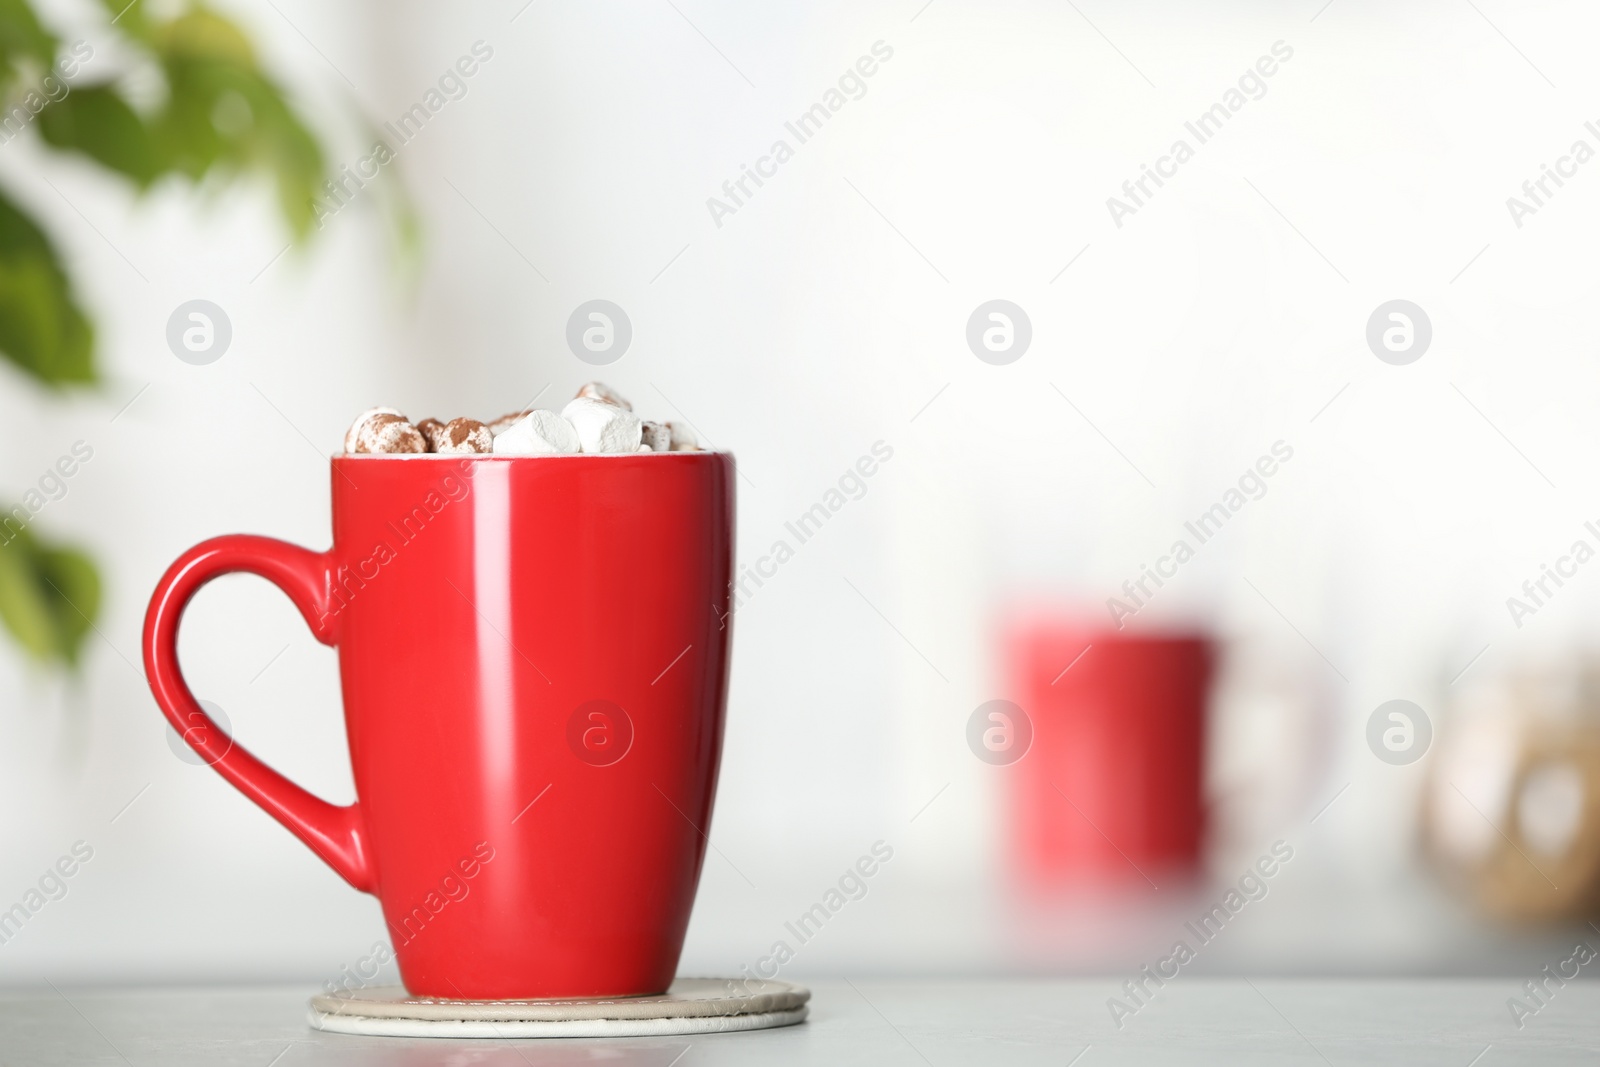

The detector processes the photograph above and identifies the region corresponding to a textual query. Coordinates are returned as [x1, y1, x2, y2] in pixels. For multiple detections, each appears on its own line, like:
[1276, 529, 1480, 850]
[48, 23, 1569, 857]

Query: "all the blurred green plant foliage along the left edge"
[0, 0, 360, 684]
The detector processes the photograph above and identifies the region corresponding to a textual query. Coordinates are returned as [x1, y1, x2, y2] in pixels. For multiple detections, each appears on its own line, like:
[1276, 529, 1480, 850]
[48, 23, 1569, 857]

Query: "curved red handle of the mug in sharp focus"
[144, 534, 376, 893]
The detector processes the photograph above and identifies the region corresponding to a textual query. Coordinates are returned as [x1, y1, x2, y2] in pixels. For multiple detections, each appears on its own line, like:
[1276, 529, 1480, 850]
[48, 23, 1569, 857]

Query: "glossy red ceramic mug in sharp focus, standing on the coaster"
[144, 453, 733, 1000]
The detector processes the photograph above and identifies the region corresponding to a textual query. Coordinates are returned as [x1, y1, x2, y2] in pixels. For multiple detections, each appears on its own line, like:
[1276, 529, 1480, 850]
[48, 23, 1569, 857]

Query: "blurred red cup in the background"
[1005, 619, 1214, 889]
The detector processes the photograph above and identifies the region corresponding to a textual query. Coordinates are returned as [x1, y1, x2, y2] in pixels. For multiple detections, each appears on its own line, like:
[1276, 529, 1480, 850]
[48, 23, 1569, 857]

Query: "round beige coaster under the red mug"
[310, 977, 811, 1038]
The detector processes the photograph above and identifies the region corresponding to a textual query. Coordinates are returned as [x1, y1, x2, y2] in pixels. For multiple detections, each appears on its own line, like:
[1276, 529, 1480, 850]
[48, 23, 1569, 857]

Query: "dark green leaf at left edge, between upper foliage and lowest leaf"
[0, 185, 94, 386]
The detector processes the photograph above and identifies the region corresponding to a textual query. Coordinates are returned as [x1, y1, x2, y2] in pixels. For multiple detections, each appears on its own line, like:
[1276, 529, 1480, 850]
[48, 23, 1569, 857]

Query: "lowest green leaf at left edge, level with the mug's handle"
[0, 524, 101, 667]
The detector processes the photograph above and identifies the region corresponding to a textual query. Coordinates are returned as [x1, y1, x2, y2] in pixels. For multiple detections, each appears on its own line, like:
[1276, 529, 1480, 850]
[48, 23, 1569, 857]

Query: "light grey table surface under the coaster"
[0, 976, 1600, 1067]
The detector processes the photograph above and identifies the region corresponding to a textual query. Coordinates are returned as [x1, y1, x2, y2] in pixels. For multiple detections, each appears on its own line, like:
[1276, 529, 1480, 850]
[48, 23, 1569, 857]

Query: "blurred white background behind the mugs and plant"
[0, 0, 1600, 982]
